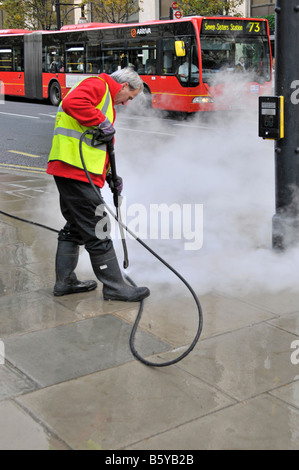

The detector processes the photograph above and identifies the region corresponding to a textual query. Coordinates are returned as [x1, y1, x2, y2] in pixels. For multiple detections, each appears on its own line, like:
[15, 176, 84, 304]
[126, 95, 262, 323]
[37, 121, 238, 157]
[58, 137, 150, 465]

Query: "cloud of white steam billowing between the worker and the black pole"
[99, 103, 299, 294]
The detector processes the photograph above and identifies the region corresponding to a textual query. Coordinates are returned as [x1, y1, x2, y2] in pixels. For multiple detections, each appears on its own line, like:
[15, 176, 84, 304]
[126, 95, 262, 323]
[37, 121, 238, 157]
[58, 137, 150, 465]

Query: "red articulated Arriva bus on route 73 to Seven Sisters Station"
[0, 17, 272, 113]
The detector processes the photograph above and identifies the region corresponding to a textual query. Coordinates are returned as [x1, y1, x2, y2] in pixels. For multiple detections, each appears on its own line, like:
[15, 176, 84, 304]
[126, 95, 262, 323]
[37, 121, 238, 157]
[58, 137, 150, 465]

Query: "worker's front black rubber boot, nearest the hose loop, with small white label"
[90, 247, 150, 302]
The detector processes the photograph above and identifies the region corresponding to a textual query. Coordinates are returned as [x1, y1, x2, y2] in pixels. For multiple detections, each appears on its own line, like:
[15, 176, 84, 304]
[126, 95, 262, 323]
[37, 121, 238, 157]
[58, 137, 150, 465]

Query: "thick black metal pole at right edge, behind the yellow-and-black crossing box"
[272, 0, 299, 250]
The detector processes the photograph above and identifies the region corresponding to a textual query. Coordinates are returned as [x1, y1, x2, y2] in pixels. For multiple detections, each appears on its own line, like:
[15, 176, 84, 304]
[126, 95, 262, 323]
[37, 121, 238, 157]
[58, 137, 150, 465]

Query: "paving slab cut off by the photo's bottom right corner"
[127, 395, 299, 451]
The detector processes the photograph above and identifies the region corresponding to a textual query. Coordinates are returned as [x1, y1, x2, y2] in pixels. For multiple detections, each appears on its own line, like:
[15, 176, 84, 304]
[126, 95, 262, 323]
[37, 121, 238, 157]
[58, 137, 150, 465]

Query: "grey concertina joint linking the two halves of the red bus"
[24, 33, 43, 99]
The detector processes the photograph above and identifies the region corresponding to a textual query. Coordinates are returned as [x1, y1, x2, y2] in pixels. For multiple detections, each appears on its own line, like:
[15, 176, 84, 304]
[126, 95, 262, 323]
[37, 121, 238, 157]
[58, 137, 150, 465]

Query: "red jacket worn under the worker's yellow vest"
[47, 73, 121, 188]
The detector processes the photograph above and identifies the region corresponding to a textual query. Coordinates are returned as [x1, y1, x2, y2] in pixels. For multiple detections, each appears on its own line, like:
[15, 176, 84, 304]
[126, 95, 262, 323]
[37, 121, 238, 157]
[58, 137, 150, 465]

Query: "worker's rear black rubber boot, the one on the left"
[54, 240, 97, 297]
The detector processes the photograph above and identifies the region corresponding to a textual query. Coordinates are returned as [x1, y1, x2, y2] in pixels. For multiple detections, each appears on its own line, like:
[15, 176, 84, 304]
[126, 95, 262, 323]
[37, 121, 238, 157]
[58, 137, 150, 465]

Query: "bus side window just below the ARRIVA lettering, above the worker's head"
[128, 40, 157, 75]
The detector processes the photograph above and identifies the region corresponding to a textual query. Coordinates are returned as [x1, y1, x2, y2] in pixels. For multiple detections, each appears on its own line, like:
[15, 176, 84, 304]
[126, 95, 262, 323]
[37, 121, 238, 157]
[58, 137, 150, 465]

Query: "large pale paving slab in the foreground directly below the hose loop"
[17, 362, 234, 450]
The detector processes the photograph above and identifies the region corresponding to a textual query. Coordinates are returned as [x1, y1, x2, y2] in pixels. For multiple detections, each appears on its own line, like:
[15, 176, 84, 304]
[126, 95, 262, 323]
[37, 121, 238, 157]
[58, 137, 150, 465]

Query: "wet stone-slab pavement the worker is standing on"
[0, 168, 299, 455]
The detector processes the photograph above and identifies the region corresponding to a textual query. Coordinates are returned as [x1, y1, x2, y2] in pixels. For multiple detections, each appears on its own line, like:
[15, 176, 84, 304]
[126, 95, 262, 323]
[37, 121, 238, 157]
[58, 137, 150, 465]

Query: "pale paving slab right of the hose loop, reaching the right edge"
[163, 323, 298, 401]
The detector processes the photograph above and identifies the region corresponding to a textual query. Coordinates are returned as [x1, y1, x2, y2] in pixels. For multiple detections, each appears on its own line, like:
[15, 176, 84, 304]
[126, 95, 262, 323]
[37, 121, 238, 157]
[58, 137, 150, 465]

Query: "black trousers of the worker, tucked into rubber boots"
[54, 176, 113, 256]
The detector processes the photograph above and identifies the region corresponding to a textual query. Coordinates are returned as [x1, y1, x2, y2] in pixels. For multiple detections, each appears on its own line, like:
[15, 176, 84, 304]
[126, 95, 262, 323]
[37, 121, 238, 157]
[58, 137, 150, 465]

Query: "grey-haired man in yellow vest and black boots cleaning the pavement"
[47, 68, 150, 302]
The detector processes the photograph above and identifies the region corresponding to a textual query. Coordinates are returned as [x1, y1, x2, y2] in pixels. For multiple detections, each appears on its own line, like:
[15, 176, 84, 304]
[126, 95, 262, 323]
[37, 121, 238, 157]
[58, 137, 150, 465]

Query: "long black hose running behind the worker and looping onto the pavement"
[0, 130, 203, 367]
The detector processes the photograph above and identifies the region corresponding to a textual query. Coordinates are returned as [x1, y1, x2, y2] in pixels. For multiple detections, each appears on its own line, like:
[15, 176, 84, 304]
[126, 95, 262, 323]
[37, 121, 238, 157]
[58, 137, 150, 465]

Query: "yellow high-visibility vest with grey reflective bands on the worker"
[49, 77, 114, 175]
